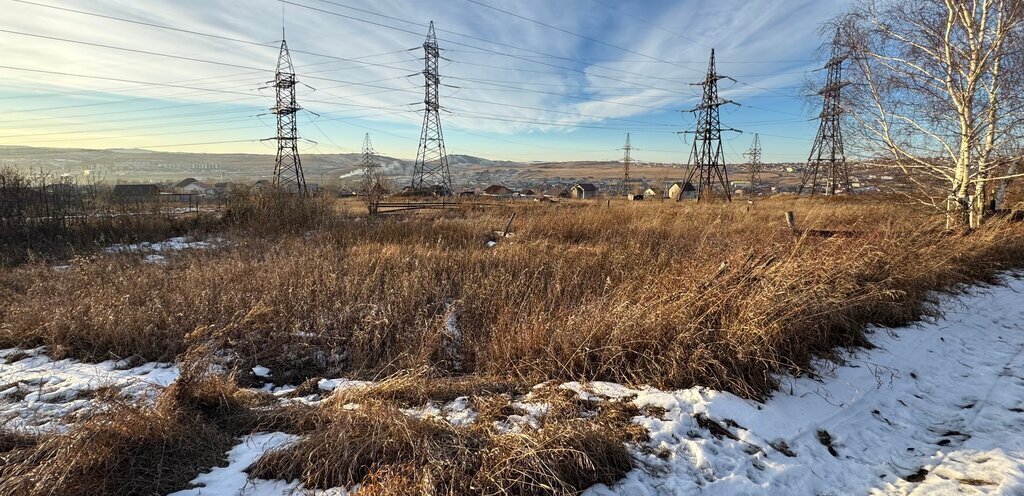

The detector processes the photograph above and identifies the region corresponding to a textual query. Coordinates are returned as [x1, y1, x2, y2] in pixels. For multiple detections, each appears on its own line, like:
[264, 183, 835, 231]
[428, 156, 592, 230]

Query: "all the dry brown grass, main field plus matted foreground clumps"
[0, 191, 1024, 494]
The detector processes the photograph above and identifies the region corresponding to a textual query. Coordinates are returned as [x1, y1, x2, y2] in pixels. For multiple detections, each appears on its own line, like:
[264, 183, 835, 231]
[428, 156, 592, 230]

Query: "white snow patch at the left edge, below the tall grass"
[0, 348, 178, 431]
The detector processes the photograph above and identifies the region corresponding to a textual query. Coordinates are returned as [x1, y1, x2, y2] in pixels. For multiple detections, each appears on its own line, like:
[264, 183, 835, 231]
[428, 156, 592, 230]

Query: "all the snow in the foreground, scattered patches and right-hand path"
[0, 275, 1024, 496]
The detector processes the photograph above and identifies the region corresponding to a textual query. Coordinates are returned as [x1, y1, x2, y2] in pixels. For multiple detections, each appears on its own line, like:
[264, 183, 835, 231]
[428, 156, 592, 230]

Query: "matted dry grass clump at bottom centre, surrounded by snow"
[250, 389, 635, 495]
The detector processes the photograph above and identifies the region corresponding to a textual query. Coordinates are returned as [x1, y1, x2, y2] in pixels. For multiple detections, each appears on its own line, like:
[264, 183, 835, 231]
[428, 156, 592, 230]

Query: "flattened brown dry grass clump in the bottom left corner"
[0, 355, 323, 496]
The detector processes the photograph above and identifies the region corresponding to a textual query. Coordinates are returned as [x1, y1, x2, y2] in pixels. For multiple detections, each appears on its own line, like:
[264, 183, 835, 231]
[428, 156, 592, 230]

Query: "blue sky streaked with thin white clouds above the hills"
[0, 0, 846, 163]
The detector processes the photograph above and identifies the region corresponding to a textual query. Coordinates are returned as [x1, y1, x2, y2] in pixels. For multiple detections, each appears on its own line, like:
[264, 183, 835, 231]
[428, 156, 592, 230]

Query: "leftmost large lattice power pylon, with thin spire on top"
[270, 30, 308, 195]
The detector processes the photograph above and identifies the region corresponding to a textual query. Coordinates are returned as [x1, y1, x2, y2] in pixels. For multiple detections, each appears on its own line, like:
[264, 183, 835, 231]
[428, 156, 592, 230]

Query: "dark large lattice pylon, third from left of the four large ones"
[679, 48, 737, 201]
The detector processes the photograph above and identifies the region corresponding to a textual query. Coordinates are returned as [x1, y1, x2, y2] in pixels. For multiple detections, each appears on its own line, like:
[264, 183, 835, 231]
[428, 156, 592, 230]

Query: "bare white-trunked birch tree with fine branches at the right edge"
[837, 0, 1024, 226]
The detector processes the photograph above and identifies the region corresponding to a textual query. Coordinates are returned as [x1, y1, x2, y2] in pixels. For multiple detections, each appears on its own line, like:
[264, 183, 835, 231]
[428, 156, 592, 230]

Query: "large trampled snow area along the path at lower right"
[578, 276, 1024, 496]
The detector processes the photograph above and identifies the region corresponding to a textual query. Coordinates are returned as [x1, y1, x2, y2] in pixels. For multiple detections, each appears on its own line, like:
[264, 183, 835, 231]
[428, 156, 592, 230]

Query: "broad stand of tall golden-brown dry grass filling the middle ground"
[0, 195, 1024, 397]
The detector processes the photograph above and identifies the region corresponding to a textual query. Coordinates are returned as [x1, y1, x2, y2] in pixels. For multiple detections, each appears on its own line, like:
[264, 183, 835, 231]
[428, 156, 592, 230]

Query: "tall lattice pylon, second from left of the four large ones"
[412, 20, 452, 197]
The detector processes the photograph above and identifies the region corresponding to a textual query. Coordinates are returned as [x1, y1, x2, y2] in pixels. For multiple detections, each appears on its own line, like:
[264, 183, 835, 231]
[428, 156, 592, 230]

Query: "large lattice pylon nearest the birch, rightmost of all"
[799, 30, 853, 196]
